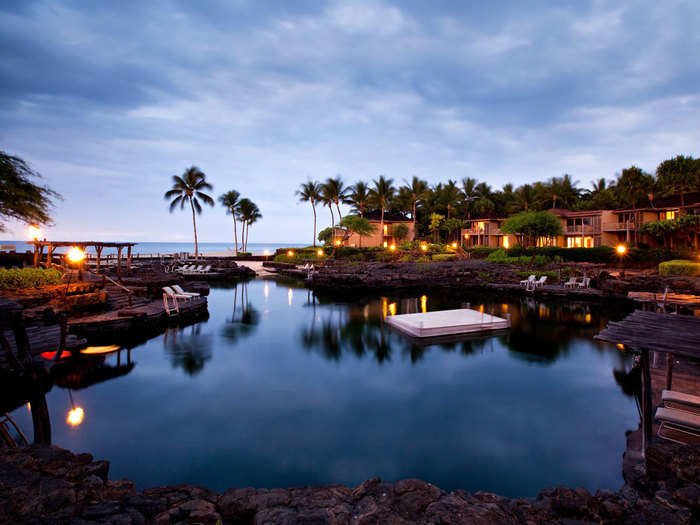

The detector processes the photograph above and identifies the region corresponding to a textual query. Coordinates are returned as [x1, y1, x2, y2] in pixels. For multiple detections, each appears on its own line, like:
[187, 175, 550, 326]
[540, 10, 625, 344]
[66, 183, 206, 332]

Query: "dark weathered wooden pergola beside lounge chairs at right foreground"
[595, 310, 700, 450]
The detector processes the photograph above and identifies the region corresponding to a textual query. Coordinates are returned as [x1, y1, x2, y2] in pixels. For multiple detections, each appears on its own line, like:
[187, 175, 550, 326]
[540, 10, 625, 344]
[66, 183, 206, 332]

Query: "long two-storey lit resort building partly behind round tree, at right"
[461, 191, 700, 249]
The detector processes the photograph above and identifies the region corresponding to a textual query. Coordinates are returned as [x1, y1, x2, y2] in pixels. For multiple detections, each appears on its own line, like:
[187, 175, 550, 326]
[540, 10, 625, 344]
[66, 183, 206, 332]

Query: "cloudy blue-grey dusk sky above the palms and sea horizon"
[0, 0, 700, 243]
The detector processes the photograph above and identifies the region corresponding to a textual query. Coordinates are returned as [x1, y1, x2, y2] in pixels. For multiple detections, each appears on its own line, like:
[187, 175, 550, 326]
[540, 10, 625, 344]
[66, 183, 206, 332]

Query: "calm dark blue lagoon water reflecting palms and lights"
[8, 281, 639, 496]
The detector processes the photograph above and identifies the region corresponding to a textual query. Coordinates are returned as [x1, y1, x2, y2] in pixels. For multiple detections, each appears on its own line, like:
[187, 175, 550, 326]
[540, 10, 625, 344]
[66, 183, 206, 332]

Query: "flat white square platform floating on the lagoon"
[386, 308, 510, 337]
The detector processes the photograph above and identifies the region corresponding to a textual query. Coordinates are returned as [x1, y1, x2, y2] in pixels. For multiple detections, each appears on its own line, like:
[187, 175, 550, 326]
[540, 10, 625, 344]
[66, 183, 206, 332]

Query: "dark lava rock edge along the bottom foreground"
[0, 443, 700, 525]
